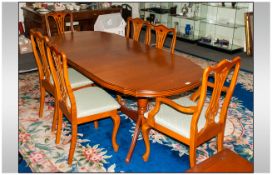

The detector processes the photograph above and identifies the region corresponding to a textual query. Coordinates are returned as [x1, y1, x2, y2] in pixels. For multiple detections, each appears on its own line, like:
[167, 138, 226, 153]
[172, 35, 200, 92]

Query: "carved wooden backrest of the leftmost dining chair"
[30, 29, 51, 84]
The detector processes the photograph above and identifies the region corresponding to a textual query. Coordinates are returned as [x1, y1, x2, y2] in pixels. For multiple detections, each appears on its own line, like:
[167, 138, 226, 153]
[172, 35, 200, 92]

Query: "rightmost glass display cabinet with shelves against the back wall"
[198, 3, 248, 52]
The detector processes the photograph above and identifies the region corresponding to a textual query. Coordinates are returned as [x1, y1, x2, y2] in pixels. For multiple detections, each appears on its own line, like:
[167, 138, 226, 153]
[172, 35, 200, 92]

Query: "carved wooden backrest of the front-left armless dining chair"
[46, 44, 76, 120]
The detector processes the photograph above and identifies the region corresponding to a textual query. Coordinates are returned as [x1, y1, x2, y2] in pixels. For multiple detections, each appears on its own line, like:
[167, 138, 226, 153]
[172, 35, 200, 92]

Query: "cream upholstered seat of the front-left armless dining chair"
[74, 87, 120, 118]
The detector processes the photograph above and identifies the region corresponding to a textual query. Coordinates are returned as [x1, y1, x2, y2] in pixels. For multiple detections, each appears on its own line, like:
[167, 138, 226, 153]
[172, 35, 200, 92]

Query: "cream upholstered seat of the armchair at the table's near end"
[144, 96, 220, 138]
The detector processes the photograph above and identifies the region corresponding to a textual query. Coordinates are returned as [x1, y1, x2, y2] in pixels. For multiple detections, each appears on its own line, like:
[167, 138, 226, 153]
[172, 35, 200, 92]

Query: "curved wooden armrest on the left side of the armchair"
[147, 97, 196, 126]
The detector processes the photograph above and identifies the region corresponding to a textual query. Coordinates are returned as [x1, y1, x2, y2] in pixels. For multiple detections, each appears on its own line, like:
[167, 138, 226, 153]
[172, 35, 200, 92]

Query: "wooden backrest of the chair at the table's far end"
[45, 11, 74, 36]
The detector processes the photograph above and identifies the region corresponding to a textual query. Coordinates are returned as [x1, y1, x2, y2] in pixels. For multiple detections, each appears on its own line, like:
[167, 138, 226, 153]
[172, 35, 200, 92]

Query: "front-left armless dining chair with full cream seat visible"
[47, 45, 120, 165]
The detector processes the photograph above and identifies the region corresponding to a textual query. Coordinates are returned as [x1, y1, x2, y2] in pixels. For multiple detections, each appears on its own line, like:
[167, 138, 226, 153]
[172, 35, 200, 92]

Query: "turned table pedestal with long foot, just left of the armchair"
[126, 98, 148, 163]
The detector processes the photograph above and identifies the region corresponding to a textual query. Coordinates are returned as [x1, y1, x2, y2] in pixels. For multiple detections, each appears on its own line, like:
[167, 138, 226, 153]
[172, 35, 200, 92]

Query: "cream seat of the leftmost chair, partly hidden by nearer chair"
[50, 68, 93, 89]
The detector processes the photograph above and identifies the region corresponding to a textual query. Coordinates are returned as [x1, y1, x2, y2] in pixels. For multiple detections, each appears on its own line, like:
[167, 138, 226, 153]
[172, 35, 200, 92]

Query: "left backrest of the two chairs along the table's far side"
[126, 17, 150, 45]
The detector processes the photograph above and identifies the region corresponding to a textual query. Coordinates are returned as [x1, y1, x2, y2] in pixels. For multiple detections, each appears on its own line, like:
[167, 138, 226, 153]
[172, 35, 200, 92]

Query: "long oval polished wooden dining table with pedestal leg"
[49, 31, 203, 163]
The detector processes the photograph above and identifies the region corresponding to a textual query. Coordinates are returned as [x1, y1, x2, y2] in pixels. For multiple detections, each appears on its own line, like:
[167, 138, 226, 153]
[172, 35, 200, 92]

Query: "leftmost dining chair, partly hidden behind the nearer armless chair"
[30, 29, 94, 131]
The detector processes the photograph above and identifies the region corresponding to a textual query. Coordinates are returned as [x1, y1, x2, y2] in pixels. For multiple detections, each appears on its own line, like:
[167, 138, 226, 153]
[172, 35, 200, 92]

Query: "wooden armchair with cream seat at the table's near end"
[142, 57, 240, 167]
